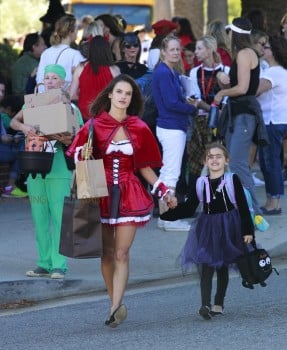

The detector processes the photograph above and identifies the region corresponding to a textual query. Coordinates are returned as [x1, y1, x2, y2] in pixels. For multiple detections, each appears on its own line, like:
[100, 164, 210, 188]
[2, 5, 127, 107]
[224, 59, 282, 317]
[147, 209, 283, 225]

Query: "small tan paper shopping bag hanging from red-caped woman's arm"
[76, 119, 108, 199]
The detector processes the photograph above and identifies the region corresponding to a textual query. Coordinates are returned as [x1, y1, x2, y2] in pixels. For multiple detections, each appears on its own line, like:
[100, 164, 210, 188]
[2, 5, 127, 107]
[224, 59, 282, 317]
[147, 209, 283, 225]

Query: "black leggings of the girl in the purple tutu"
[200, 264, 229, 307]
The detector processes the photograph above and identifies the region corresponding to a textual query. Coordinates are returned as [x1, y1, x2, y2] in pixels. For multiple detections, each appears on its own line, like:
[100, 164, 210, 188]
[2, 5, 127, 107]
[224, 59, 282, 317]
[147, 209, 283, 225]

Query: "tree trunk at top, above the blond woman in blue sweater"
[174, 0, 204, 38]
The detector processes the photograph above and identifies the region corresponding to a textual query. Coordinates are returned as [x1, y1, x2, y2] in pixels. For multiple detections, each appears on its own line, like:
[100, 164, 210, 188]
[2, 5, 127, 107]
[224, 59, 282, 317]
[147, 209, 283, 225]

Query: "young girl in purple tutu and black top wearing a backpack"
[161, 143, 254, 320]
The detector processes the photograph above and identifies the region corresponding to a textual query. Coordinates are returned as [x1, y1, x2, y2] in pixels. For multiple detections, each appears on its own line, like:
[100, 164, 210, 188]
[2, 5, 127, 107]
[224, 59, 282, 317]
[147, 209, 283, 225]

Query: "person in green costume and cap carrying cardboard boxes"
[11, 64, 83, 279]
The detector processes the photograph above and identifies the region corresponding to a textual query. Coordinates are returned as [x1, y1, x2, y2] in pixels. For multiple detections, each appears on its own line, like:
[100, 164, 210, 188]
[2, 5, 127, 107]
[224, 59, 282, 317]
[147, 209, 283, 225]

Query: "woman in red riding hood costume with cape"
[67, 74, 177, 327]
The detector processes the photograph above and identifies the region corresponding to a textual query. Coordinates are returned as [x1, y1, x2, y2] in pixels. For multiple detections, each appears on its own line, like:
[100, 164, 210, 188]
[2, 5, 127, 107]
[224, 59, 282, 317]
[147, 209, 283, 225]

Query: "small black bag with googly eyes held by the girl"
[236, 241, 279, 289]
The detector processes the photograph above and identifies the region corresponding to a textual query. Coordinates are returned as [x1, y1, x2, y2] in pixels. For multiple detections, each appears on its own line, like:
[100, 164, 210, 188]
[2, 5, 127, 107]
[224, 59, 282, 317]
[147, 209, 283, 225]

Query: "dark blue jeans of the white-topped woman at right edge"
[259, 123, 287, 198]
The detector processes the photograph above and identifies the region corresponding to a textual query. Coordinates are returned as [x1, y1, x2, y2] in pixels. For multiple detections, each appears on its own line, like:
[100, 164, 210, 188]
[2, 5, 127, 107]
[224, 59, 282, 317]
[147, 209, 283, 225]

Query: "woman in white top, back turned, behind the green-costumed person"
[36, 15, 85, 92]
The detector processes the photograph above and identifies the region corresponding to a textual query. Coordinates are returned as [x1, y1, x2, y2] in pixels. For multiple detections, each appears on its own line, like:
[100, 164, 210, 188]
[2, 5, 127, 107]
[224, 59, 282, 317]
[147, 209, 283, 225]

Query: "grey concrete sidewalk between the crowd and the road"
[0, 187, 287, 304]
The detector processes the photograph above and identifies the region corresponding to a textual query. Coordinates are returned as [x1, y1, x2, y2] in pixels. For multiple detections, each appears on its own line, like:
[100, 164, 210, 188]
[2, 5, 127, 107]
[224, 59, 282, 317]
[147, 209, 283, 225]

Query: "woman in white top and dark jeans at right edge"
[257, 36, 287, 215]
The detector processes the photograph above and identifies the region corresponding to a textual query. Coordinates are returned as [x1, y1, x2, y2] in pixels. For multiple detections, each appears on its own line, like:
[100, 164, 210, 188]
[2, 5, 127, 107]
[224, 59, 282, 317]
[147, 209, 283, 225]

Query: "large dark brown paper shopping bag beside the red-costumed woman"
[59, 174, 103, 259]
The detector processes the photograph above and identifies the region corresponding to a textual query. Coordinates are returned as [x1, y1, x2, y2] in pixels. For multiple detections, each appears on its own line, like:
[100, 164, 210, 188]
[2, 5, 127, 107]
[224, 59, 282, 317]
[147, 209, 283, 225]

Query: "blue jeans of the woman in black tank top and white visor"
[225, 113, 261, 215]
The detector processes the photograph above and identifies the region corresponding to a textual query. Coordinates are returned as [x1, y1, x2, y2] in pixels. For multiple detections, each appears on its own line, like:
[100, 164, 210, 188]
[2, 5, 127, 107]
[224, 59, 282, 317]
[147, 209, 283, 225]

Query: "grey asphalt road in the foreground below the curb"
[0, 268, 287, 350]
